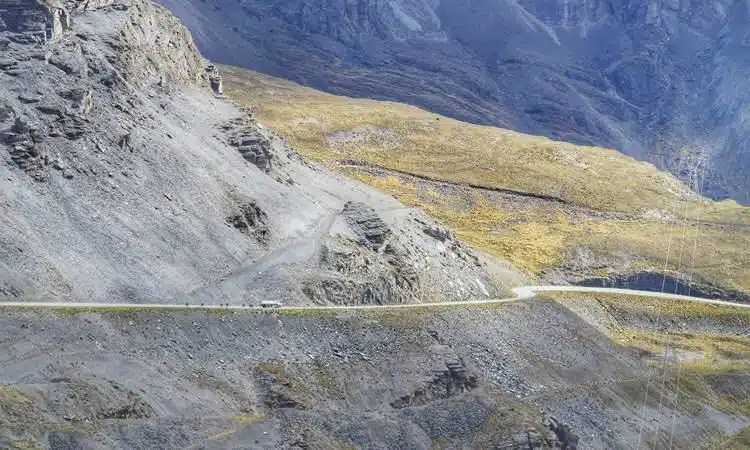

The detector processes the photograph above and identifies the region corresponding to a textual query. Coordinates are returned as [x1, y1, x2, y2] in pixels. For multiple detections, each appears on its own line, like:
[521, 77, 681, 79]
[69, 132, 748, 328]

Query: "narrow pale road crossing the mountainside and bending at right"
[0, 286, 750, 310]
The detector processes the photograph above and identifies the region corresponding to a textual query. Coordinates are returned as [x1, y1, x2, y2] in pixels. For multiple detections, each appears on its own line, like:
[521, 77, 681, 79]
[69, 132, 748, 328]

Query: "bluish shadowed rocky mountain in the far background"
[159, 0, 750, 203]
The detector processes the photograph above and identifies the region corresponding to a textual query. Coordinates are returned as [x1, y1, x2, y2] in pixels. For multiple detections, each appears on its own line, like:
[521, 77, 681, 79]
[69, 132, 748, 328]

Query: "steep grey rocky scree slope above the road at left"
[0, 0, 514, 304]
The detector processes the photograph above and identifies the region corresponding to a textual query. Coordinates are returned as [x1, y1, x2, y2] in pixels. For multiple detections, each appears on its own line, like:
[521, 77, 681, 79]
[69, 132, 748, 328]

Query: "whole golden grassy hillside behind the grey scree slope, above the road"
[224, 68, 750, 292]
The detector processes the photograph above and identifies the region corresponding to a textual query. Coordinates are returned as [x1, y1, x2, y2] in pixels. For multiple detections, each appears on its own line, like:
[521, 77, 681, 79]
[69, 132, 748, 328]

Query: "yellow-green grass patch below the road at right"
[541, 292, 750, 426]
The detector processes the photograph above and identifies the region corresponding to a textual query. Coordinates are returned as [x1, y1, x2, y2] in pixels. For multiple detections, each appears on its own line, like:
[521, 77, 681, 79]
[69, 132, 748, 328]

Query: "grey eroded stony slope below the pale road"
[0, 296, 750, 449]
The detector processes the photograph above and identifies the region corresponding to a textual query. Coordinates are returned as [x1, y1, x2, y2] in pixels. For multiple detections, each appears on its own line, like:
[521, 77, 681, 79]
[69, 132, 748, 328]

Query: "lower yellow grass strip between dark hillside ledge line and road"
[353, 173, 750, 292]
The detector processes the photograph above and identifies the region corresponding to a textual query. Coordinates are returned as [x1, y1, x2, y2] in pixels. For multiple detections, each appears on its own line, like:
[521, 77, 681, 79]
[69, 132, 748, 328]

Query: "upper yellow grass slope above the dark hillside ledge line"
[223, 68, 750, 223]
